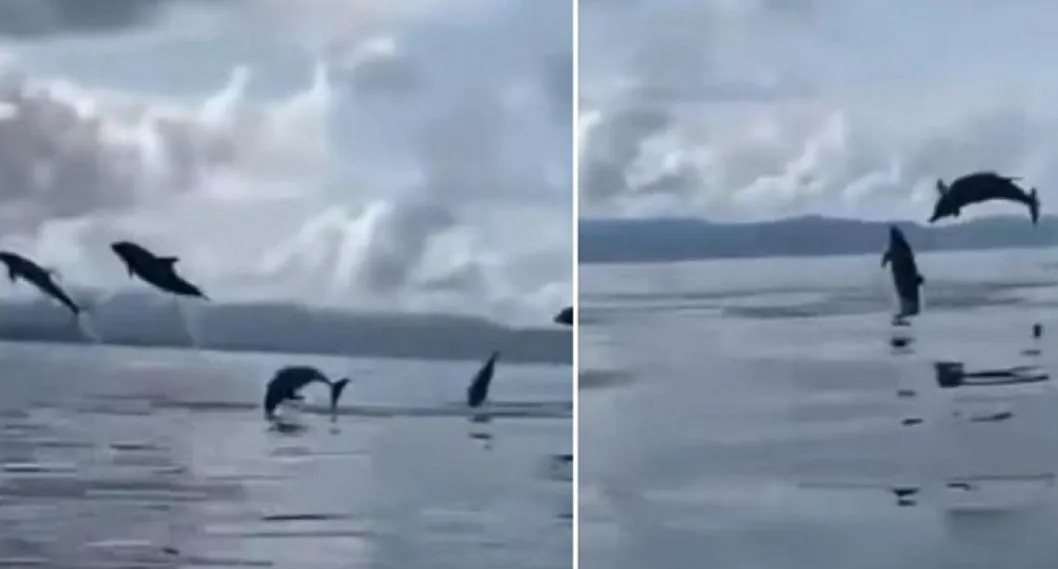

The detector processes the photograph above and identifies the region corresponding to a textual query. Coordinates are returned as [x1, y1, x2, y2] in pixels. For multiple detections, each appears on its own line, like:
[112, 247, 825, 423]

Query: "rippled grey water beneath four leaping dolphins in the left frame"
[0, 345, 572, 569]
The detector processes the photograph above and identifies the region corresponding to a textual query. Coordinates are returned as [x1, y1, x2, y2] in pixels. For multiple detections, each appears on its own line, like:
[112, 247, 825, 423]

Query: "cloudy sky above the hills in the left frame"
[0, 0, 572, 324]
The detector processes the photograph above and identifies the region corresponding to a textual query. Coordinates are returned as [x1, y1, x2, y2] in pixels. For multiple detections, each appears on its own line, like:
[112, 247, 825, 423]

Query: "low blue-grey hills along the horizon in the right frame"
[580, 216, 1058, 263]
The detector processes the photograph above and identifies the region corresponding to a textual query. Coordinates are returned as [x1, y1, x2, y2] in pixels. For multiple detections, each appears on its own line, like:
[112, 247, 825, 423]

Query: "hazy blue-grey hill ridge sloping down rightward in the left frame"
[0, 291, 573, 364]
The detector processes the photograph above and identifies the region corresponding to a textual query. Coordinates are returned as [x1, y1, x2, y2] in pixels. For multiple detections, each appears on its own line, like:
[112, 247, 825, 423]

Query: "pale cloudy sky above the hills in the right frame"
[578, 0, 1058, 221]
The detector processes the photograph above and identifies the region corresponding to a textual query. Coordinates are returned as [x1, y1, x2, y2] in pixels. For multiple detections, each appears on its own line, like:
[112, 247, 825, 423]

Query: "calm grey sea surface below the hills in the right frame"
[577, 250, 1058, 569]
